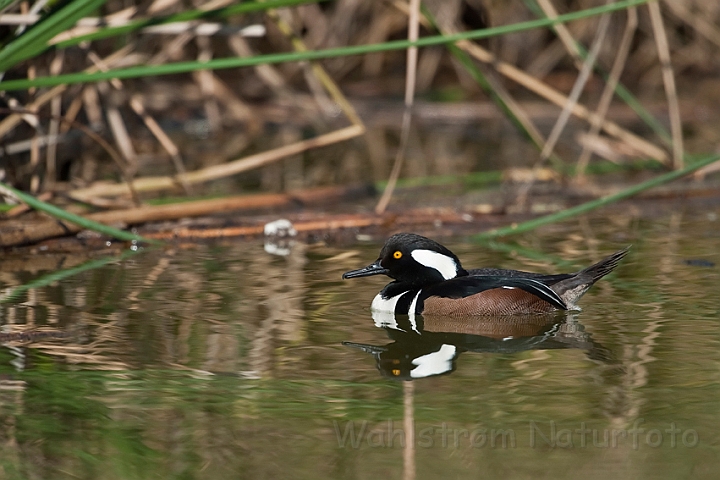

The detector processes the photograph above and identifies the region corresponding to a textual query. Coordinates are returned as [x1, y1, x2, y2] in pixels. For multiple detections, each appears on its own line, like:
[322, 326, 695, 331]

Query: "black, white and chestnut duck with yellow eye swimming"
[343, 233, 630, 315]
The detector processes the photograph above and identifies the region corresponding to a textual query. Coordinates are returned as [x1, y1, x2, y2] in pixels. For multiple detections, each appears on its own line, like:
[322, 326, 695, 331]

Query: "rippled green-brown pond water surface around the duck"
[0, 210, 720, 479]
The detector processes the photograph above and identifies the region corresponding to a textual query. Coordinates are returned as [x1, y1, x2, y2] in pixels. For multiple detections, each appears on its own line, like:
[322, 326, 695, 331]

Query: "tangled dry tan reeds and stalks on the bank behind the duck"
[0, 0, 720, 246]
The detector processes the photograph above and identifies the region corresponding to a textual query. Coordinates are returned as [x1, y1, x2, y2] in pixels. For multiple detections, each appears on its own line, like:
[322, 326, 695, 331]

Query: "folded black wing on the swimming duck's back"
[428, 275, 567, 310]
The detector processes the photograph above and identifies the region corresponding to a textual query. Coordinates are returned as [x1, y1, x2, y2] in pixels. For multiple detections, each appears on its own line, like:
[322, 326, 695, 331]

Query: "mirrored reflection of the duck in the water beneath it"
[343, 311, 610, 380]
